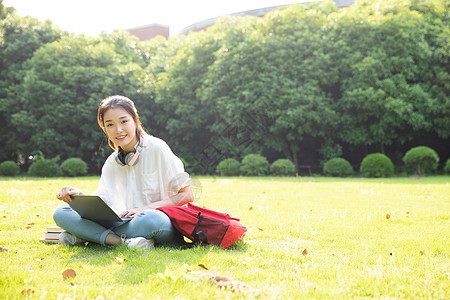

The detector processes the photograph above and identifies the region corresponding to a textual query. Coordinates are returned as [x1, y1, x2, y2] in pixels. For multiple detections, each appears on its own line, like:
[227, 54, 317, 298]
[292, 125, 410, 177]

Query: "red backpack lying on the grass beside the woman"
[157, 203, 247, 249]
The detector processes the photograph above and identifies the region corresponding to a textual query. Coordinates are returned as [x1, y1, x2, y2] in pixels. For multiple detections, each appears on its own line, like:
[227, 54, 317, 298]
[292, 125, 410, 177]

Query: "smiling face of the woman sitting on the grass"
[103, 107, 138, 152]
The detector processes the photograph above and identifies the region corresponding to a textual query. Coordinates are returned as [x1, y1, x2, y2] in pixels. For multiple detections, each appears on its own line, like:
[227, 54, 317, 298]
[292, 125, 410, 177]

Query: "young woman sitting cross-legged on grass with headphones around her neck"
[53, 96, 194, 249]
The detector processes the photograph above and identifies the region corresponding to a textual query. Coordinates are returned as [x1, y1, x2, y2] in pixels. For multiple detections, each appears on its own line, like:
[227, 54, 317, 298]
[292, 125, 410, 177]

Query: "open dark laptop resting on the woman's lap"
[70, 195, 131, 228]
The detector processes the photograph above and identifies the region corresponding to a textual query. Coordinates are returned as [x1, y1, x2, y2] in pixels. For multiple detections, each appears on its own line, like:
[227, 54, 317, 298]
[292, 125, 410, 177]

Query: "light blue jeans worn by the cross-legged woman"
[53, 204, 182, 246]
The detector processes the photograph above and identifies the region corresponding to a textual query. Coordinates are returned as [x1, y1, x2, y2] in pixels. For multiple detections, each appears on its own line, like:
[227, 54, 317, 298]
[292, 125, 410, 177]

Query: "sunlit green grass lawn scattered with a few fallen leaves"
[0, 176, 450, 299]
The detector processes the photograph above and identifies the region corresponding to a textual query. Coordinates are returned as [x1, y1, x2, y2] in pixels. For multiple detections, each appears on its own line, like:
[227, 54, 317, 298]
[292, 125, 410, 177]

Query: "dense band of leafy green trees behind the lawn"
[0, 0, 450, 173]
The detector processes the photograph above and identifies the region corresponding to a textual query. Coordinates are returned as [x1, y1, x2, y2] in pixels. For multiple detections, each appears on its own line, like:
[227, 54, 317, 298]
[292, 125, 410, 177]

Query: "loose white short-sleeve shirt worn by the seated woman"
[93, 134, 191, 214]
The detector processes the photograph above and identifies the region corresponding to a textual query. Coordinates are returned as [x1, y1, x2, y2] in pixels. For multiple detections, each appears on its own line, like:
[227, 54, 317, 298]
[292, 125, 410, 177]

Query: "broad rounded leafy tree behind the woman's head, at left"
[10, 32, 151, 171]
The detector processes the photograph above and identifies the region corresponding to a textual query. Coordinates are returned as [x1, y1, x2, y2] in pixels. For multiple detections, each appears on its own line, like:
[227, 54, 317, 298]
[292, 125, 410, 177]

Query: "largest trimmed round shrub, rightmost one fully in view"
[403, 146, 439, 175]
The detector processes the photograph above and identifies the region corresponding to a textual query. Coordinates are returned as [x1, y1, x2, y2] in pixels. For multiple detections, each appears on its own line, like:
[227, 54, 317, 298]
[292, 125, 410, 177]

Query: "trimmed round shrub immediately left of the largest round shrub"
[360, 153, 394, 177]
